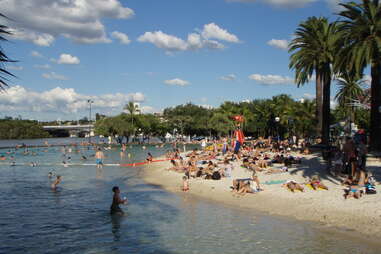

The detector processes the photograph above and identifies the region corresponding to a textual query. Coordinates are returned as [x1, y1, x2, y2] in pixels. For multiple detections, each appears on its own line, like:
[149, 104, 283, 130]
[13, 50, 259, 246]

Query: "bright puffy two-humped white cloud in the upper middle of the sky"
[138, 23, 239, 54]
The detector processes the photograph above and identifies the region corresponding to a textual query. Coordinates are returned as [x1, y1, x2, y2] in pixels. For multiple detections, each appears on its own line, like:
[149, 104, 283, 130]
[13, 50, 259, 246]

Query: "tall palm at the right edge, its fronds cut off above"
[338, 0, 381, 151]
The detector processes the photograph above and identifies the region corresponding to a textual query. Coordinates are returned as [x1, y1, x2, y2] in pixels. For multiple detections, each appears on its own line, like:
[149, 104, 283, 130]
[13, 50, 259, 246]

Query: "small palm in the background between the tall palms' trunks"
[335, 72, 366, 130]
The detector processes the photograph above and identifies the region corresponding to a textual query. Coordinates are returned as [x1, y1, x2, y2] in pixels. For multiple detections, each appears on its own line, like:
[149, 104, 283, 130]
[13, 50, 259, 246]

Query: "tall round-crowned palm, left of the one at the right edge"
[289, 17, 340, 144]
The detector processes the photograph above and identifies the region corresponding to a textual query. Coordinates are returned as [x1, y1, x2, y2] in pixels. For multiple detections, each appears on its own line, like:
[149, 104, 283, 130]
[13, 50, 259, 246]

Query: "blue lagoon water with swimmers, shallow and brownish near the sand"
[0, 139, 380, 254]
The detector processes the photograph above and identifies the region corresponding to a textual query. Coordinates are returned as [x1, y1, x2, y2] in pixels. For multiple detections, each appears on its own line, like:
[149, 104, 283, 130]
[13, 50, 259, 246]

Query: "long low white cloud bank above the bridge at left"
[0, 85, 145, 116]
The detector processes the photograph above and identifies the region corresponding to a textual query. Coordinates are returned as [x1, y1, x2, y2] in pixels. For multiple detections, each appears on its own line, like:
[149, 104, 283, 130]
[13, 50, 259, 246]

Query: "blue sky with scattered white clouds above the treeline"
[0, 0, 356, 120]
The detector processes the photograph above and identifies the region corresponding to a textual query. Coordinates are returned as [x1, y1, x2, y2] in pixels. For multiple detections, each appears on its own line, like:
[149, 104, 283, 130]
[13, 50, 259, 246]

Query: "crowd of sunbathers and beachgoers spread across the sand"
[166, 131, 376, 198]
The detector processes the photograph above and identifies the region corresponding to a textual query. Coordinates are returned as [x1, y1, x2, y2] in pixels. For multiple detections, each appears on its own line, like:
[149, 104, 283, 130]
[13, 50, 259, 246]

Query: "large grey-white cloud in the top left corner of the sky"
[0, 0, 134, 46]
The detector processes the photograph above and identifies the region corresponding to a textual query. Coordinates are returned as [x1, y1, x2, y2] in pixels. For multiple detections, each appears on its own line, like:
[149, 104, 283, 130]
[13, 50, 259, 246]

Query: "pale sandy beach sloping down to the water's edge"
[144, 155, 381, 238]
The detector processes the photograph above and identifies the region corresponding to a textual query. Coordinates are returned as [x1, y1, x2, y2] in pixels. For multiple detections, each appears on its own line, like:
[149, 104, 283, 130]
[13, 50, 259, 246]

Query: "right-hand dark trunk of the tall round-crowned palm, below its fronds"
[322, 72, 331, 145]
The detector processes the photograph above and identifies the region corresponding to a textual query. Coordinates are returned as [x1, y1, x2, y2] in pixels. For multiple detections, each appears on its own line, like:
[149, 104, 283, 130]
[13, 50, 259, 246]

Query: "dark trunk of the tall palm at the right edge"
[370, 59, 381, 151]
